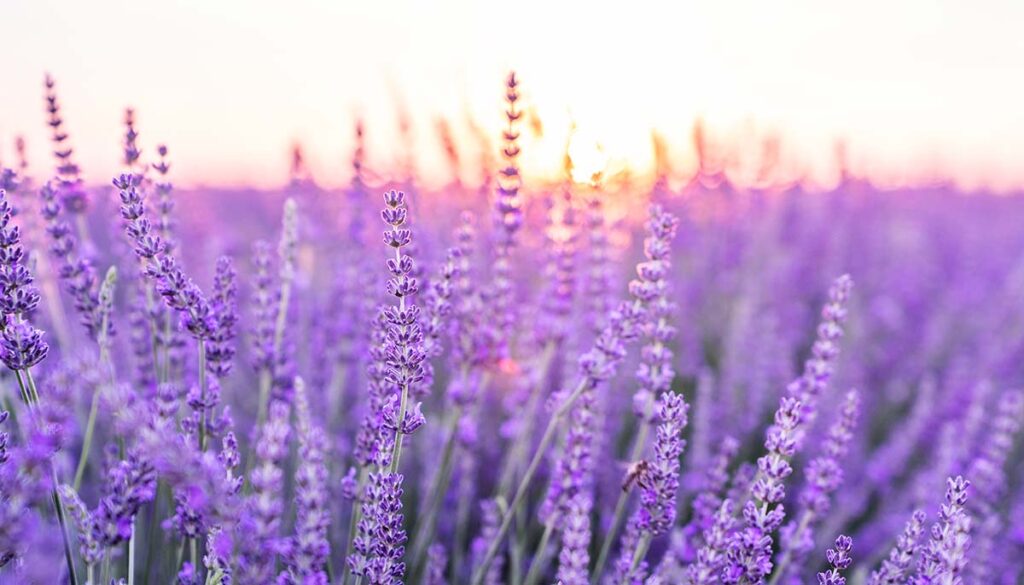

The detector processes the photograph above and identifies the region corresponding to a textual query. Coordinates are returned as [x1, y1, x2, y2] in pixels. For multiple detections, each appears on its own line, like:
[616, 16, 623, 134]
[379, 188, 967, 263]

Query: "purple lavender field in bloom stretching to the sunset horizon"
[0, 75, 1024, 585]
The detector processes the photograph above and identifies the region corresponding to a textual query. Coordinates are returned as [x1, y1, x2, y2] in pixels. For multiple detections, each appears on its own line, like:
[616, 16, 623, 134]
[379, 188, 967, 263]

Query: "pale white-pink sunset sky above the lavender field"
[0, 0, 1024, 190]
